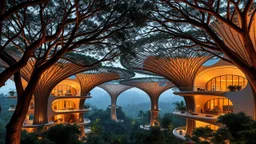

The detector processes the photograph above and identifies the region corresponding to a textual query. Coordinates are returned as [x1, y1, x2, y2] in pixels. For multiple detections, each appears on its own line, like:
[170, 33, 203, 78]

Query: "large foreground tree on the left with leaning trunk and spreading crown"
[0, 0, 152, 143]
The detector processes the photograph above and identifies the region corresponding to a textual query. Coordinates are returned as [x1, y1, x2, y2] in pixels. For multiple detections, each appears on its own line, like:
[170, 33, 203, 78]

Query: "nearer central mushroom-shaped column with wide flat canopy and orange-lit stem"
[120, 77, 175, 126]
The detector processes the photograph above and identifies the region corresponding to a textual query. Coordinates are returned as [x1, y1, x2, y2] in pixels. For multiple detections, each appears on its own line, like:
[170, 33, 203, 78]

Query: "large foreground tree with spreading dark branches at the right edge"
[153, 0, 256, 112]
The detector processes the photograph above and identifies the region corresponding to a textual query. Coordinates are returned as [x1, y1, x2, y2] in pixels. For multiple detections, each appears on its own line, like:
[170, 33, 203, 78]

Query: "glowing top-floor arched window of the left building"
[51, 85, 77, 96]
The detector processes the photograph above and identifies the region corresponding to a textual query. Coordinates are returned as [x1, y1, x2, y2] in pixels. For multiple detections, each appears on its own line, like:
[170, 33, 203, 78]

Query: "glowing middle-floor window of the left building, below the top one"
[52, 100, 75, 110]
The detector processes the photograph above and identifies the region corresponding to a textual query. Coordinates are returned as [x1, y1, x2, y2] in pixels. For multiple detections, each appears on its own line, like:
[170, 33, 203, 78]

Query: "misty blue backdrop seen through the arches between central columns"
[86, 88, 183, 118]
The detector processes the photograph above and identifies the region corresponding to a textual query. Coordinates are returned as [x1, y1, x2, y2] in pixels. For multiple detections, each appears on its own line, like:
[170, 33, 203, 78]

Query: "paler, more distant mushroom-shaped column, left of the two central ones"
[99, 81, 132, 122]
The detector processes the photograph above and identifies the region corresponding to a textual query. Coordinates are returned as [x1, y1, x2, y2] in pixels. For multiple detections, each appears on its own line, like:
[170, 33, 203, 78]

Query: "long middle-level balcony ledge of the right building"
[173, 111, 220, 123]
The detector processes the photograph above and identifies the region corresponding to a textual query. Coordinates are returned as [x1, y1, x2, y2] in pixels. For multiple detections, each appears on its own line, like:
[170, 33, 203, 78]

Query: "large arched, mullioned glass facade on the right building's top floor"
[206, 75, 247, 91]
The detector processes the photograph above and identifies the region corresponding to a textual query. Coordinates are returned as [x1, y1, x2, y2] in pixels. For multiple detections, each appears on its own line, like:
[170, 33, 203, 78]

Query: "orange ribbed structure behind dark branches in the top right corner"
[211, 8, 256, 66]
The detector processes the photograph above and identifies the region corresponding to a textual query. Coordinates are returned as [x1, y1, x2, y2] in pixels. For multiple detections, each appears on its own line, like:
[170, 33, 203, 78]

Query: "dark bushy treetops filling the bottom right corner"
[187, 112, 256, 144]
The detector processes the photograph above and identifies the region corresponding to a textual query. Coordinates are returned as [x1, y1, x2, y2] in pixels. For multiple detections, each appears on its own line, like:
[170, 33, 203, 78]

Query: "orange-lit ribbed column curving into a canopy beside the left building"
[21, 59, 100, 124]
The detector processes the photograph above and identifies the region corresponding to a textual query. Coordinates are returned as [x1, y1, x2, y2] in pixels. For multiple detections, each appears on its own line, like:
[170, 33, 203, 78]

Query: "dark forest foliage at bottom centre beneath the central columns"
[86, 108, 184, 144]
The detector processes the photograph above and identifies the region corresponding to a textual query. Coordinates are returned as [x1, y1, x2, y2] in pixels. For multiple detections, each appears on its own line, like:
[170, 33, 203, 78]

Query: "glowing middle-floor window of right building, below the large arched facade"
[204, 98, 234, 115]
